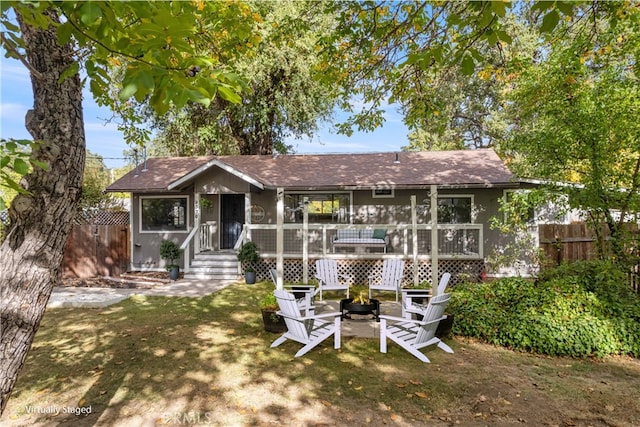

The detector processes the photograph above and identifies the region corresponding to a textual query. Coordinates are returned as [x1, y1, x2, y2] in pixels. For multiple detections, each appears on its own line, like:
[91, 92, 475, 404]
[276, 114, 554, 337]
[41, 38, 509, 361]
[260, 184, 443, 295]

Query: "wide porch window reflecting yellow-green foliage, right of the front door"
[285, 193, 351, 224]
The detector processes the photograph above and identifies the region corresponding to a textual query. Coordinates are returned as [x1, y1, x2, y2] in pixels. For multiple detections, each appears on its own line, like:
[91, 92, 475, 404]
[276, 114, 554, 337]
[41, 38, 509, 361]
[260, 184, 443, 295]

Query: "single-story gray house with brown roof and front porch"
[107, 149, 560, 282]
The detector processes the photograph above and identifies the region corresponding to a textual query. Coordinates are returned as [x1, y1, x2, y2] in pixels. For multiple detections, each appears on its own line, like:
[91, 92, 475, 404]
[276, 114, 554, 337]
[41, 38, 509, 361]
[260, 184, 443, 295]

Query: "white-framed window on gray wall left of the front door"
[140, 196, 188, 233]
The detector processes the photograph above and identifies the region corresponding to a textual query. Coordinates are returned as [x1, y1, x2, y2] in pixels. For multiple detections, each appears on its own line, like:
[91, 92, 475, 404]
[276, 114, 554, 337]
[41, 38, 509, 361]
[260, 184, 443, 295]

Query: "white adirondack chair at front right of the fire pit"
[380, 294, 453, 363]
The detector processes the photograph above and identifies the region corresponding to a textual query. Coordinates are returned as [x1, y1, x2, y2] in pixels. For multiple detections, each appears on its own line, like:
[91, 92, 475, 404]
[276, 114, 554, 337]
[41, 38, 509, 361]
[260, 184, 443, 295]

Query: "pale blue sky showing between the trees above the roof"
[0, 56, 408, 168]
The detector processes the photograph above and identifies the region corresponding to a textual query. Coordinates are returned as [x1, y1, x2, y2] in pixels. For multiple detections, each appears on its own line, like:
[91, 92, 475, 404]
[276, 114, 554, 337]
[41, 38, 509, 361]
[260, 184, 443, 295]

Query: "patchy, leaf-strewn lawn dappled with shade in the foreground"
[1, 283, 640, 426]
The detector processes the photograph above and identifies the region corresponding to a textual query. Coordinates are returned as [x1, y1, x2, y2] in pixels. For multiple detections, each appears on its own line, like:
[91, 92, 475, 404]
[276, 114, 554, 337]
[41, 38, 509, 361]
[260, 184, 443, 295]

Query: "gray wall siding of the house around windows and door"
[126, 182, 504, 270]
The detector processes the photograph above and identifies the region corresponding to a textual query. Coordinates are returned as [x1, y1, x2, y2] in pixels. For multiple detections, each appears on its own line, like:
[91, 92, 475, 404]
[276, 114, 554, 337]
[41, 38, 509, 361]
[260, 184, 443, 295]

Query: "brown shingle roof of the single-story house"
[108, 150, 514, 191]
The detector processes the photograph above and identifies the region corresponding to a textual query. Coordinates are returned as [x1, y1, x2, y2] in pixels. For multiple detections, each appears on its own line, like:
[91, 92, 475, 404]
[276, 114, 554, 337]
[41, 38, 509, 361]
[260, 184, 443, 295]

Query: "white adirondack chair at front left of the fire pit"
[271, 289, 342, 357]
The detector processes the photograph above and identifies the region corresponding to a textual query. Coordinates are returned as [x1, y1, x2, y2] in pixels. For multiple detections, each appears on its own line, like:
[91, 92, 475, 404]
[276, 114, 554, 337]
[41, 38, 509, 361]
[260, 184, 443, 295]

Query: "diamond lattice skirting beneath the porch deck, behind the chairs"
[256, 259, 484, 285]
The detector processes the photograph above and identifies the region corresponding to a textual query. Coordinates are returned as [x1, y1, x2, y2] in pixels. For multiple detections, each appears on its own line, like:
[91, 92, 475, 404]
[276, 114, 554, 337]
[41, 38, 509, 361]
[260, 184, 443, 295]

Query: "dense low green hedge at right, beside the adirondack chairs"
[449, 261, 640, 357]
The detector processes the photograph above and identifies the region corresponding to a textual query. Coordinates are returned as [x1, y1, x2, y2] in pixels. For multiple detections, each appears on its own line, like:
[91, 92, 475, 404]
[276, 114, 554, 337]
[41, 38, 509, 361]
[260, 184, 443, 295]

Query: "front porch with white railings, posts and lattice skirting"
[182, 185, 484, 286]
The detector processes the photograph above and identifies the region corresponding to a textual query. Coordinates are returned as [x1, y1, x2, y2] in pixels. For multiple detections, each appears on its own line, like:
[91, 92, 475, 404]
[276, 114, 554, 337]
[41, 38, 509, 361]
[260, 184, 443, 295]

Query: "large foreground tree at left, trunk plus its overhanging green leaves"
[0, 1, 254, 410]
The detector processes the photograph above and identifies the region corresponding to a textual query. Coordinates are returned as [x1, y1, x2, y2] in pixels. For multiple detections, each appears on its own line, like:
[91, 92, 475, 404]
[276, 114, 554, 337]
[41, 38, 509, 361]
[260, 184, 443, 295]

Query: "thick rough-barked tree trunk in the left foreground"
[0, 12, 85, 413]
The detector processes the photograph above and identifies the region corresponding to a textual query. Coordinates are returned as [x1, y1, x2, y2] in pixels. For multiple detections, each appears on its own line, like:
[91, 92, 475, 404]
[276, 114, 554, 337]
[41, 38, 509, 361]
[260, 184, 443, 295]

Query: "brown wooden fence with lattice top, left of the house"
[62, 212, 130, 279]
